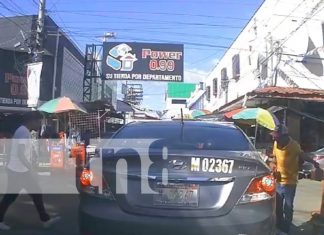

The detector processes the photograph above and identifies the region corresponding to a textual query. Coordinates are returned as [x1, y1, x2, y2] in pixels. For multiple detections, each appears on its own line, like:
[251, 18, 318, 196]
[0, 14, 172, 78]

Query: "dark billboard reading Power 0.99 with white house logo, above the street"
[102, 42, 183, 82]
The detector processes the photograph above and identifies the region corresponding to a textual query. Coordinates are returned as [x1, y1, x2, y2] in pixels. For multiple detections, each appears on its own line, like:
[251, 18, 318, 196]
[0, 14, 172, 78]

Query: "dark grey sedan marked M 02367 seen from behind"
[79, 120, 275, 235]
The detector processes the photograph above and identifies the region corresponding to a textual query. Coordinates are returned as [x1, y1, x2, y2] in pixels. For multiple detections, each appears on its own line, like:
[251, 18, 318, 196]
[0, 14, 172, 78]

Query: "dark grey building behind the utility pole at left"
[0, 15, 84, 111]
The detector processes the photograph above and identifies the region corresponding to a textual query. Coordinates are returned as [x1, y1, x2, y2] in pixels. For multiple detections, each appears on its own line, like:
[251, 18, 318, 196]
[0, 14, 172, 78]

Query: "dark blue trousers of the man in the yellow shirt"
[276, 184, 297, 233]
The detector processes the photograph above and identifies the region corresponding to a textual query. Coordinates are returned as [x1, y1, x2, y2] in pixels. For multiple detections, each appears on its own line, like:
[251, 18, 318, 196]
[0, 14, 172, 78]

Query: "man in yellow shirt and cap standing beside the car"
[271, 125, 319, 234]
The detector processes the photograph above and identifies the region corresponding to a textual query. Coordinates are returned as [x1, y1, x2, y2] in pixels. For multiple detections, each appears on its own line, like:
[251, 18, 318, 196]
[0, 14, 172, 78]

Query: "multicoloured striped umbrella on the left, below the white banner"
[38, 97, 87, 113]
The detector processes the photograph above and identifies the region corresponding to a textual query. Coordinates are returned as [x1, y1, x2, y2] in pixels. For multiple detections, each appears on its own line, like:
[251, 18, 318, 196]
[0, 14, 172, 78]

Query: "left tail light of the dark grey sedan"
[80, 169, 115, 200]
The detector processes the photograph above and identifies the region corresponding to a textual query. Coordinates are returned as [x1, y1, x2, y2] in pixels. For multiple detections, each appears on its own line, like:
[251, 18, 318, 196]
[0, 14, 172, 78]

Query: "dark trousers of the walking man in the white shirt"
[0, 170, 49, 222]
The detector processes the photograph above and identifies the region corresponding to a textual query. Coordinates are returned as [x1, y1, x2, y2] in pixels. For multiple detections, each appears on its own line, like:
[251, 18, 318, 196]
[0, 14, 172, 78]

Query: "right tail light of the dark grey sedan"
[239, 175, 276, 204]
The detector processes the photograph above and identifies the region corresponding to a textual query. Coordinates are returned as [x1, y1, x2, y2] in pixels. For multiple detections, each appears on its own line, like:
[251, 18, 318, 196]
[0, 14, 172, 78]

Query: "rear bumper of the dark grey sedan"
[79, 198, 275, 235]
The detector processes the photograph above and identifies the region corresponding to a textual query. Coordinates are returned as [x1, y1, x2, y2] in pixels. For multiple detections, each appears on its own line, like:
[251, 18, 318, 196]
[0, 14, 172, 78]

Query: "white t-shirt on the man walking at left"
[7, 125, 32, 172]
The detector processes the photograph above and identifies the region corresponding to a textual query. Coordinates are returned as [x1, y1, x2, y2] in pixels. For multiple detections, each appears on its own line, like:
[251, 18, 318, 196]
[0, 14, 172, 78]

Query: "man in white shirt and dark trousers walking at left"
[0, 112, 60, 230]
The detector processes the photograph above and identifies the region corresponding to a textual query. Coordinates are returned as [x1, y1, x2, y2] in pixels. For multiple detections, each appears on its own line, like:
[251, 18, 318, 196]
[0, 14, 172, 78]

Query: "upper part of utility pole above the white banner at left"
[34, 0, 46, 62]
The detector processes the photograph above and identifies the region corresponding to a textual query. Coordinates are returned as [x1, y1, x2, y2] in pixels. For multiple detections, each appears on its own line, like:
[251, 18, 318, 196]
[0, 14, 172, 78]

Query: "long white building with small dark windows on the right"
[204, 0, 324, 111]
